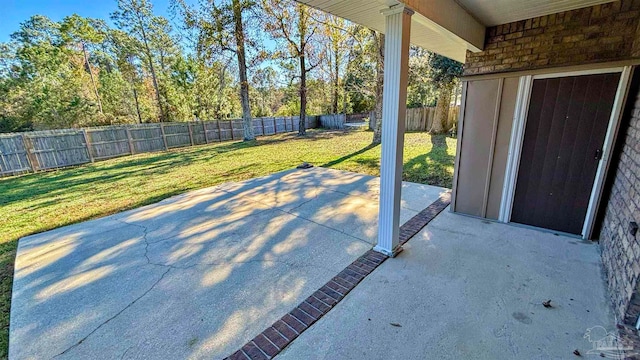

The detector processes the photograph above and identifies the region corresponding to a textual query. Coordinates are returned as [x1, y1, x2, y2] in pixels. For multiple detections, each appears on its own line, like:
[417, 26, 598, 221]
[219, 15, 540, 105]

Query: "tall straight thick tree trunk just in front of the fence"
[232, 0, 256, 141]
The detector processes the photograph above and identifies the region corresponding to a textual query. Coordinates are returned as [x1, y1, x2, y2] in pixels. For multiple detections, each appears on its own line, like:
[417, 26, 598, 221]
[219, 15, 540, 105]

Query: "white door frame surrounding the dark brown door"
[498, 66, 632, 239]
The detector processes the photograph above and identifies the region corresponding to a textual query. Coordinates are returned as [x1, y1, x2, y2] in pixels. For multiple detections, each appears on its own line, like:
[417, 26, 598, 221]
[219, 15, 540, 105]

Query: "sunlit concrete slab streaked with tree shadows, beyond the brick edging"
[9, 168, 445, 359]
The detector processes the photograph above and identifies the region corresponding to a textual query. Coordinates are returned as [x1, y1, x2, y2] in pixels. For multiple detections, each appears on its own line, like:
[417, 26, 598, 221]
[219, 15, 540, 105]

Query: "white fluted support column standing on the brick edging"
[374, 5, 413, 257]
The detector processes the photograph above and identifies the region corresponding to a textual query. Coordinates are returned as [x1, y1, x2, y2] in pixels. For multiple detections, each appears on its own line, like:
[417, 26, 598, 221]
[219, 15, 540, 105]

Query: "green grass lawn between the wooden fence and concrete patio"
[0, 130, 456, 358]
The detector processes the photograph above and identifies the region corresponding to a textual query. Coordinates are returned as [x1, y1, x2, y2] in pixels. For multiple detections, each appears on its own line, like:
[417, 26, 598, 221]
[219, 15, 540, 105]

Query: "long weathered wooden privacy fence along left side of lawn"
[0, 116, 319, 176]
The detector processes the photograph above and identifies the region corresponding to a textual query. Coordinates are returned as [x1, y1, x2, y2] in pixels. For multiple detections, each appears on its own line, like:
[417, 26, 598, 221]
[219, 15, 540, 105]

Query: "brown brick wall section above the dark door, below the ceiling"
[464, 0, 640, 75]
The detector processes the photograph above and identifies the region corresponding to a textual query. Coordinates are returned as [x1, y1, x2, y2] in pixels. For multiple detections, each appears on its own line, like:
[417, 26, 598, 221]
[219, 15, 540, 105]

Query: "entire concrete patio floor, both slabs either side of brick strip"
[10, 168, 613, 359]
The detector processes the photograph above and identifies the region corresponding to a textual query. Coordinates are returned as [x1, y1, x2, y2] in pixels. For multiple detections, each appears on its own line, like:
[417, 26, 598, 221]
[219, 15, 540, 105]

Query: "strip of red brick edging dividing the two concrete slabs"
[225, 191, 451, 360]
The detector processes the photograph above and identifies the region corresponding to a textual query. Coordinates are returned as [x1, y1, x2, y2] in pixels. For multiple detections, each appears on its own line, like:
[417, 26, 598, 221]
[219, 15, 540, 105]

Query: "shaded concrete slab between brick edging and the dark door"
[277, 211, 615, 359]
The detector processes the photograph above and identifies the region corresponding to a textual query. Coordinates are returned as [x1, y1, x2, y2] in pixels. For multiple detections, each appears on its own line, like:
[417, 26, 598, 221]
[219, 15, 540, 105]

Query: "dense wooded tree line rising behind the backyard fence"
[0, 0, 461, 132]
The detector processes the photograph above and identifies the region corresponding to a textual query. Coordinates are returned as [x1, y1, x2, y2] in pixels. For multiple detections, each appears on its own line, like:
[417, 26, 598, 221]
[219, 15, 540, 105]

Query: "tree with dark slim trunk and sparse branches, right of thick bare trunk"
[263, 0, 323, 136]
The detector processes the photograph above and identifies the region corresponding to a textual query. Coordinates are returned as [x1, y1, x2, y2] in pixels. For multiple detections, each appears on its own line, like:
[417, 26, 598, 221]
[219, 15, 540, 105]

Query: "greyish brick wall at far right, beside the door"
[600, 70, 640, 325]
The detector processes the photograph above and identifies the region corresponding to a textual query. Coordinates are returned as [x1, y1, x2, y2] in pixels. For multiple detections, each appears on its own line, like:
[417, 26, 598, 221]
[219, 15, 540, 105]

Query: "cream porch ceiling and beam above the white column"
[297, 0, 612, 62]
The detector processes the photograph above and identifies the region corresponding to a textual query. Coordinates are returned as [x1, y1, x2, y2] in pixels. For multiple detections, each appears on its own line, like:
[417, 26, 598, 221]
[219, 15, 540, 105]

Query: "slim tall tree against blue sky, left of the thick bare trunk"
[111, 0, 166, 122]
